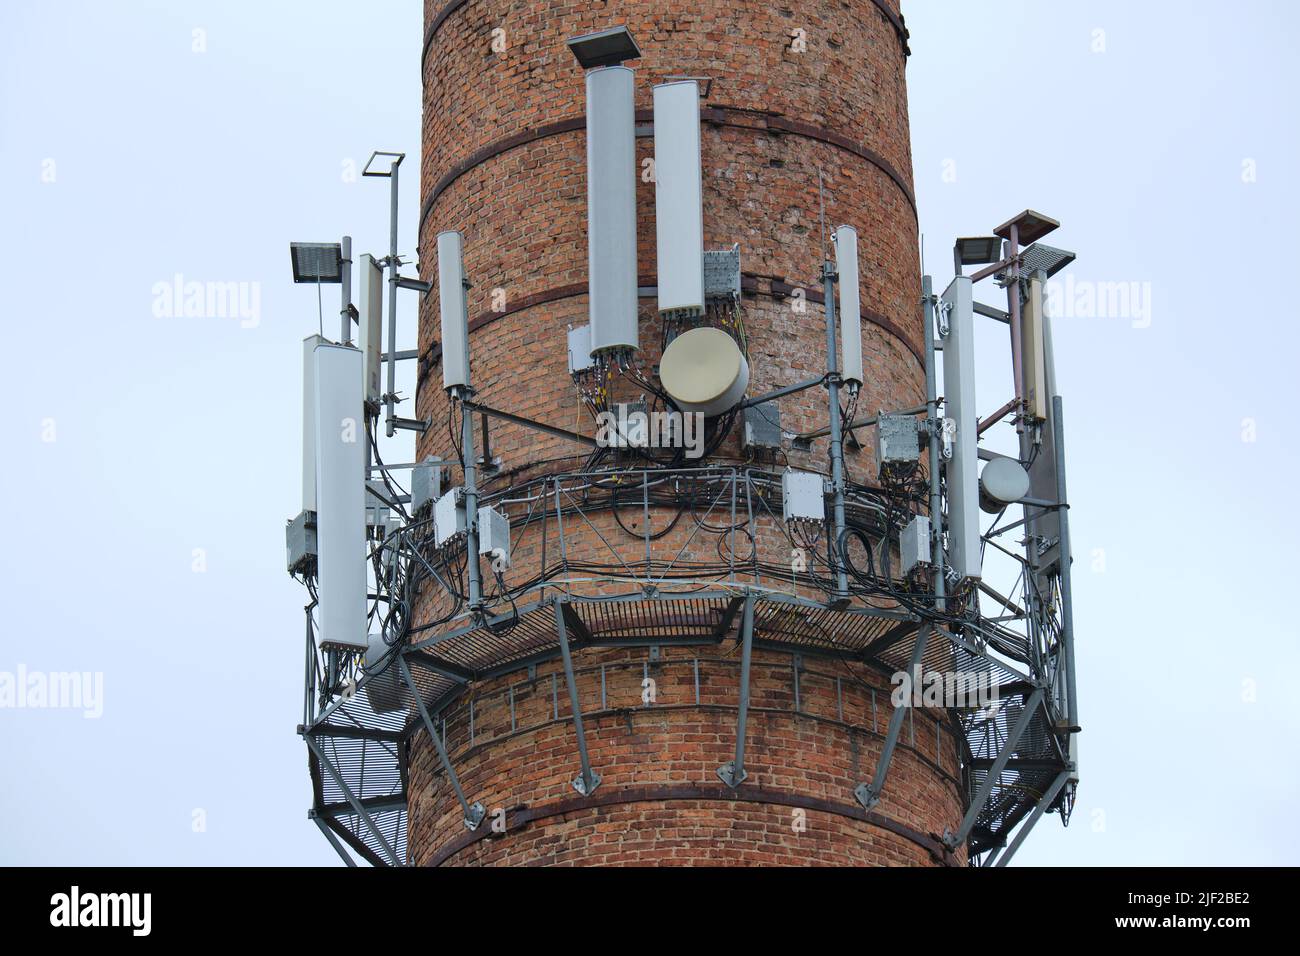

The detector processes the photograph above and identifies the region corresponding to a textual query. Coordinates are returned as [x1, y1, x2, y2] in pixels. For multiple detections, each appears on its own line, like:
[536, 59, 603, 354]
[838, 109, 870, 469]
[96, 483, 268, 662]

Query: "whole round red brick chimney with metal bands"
[404, 0, 965, 866]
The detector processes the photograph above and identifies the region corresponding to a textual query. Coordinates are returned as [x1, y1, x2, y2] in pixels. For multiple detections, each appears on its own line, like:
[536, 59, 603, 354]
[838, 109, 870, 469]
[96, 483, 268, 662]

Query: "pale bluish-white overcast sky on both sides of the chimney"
[0, 0, 1300, 865]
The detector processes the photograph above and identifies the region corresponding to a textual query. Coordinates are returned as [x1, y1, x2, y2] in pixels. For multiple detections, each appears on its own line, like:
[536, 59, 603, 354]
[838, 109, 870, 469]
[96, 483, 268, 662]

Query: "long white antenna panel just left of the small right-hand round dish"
[941, 276, 980, 578]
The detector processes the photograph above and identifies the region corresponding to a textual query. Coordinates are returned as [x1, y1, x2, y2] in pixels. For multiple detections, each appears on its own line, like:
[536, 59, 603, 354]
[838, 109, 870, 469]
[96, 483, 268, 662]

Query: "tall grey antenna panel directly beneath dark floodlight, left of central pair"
[586, 66, 638, 355]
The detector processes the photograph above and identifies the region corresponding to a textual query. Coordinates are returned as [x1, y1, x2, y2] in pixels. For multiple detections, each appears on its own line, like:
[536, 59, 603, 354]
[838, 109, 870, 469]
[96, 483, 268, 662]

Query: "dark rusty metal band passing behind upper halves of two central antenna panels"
[420, 107, 917, 239]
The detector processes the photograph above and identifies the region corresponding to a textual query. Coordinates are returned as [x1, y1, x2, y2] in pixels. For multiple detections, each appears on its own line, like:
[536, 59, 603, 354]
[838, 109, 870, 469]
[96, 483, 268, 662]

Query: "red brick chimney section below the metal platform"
[408, 641, 962, 865]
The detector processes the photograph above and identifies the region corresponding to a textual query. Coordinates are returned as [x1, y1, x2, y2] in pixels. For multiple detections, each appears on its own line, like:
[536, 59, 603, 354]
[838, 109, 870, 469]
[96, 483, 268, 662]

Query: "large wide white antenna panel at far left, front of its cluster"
[315, 345, 367, 644]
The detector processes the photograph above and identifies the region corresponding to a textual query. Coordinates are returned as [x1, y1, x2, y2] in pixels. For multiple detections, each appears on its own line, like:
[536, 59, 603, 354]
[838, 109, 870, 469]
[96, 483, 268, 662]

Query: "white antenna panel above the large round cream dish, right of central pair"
[654, 79, 705, 313]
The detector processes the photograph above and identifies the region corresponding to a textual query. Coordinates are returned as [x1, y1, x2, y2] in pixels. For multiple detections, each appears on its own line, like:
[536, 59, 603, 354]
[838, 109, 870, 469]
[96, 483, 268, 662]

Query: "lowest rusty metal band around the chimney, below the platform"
[425, 784, 962, 866]
